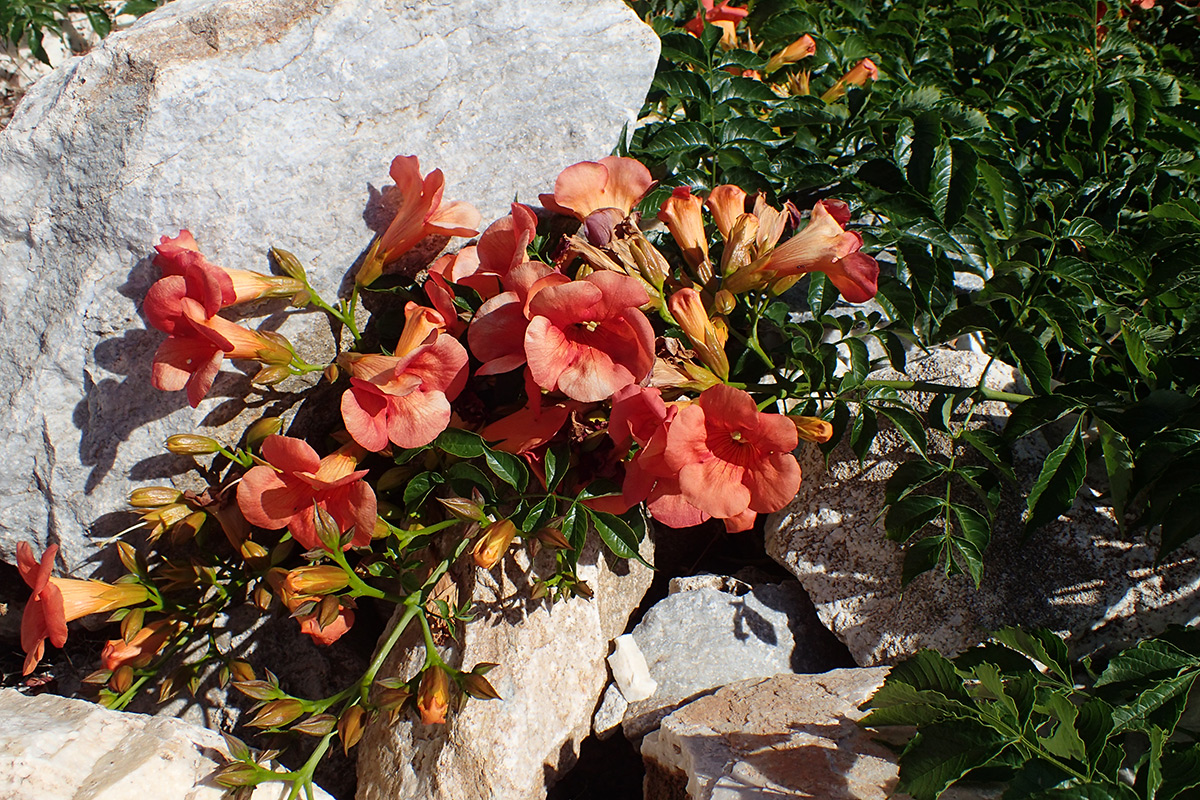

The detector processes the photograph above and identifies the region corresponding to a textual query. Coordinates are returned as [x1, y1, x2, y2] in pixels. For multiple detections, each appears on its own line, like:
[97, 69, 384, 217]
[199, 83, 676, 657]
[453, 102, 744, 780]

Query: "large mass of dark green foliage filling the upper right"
[629, 0, 1200, 582]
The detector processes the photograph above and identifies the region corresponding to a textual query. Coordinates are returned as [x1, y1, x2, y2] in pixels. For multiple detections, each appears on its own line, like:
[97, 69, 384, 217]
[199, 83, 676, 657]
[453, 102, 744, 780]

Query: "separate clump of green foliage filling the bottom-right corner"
[862, 628, 1200, 800]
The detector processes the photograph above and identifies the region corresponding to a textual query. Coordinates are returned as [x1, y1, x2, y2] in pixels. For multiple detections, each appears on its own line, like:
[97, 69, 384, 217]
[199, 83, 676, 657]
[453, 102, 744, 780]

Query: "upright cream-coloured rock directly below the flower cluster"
[358, 539, 652, 800]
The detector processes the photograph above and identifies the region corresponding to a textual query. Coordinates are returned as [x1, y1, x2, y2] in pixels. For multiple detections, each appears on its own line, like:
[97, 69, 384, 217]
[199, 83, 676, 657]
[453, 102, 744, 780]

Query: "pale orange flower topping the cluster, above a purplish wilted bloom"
[538, 156, 654, 222]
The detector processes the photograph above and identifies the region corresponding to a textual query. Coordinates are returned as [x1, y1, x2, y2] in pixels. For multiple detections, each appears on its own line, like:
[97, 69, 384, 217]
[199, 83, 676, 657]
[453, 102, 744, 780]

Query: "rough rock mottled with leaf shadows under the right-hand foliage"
[766, 350, 1200, 666]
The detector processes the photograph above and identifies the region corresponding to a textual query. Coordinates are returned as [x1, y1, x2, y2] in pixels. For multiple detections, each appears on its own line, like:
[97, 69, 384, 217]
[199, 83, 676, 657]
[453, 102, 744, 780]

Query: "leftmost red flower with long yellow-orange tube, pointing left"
[17, 542, 150, 675]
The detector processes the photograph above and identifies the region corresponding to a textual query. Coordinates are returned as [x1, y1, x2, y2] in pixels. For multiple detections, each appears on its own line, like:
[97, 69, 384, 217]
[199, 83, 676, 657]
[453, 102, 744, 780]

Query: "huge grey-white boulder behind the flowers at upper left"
[0, 0, 658, 570]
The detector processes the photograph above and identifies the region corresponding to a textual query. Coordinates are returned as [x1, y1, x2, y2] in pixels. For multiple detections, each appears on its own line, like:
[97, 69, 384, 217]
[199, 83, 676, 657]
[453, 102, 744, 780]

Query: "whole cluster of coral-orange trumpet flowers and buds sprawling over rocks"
[20, 151, 878, 784]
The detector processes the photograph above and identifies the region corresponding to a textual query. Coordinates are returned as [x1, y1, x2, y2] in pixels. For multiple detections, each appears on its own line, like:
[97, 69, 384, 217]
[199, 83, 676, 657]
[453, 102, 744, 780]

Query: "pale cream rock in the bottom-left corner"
[0, 688, 330, 800]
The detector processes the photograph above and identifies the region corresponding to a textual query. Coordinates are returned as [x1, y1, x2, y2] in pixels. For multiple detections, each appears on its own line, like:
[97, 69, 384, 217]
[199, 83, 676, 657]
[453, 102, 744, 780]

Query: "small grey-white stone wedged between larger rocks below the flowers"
[619, 582, 844, 739]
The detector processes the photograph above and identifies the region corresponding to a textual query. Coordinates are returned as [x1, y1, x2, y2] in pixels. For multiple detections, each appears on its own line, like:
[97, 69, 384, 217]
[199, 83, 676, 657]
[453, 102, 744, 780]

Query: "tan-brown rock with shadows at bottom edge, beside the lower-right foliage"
[642, 667, 1000, 800]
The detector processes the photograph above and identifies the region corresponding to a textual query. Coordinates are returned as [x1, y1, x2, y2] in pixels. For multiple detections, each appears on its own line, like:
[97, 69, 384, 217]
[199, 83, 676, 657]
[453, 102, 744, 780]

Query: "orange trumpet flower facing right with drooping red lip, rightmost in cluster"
[724, 201, 880, 302]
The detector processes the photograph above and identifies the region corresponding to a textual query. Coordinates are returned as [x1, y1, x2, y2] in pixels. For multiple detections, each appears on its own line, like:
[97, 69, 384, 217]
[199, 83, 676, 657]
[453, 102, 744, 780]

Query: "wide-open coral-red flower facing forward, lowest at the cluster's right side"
[664, 385, 800, 519]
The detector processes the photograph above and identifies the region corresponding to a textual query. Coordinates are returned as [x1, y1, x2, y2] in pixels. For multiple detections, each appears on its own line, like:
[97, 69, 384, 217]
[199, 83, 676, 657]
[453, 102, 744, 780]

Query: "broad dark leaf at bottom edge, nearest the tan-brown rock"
[896, 721, 1010, 800]
